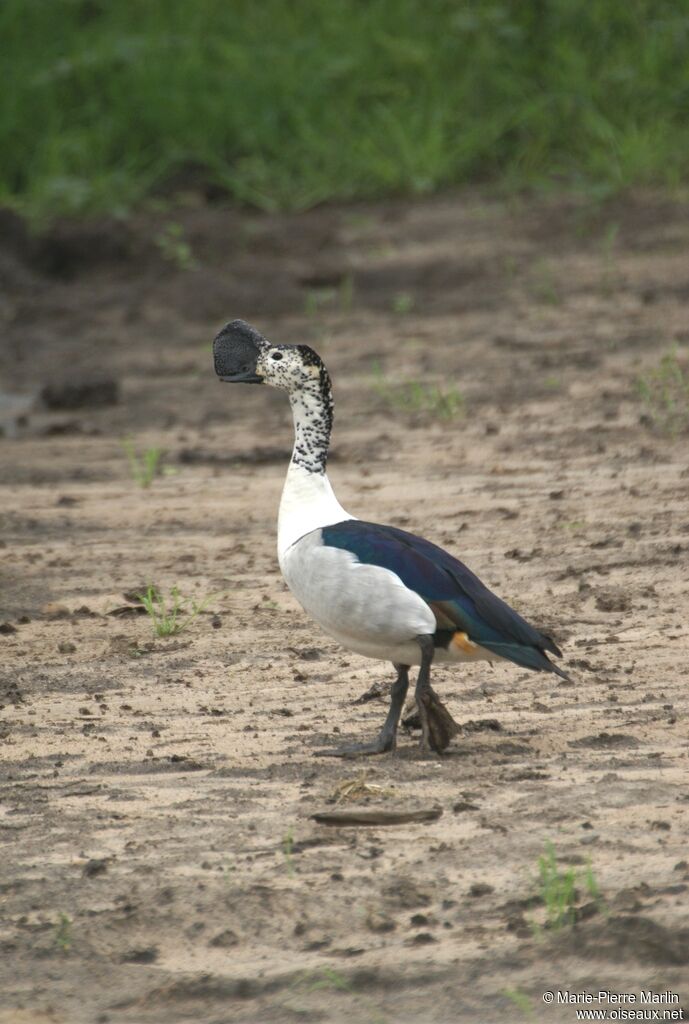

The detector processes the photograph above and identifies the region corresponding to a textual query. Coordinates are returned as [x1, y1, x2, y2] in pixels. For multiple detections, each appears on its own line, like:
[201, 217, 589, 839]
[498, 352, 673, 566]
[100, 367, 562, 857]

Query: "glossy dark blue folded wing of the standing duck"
[322, 519, 566, 678]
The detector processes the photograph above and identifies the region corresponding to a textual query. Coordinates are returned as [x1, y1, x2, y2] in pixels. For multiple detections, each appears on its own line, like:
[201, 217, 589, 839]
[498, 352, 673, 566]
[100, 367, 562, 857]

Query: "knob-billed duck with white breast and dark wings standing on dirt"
[213, 319, 569, 757]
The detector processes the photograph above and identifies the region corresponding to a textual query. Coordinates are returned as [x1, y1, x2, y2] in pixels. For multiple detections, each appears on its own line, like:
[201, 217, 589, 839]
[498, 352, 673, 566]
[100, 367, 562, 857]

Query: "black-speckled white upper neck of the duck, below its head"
[289, 345, 333, 473]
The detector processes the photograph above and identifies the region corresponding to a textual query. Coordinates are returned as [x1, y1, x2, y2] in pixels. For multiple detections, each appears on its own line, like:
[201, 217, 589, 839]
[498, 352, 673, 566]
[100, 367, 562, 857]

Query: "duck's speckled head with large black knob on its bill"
[213, 321, 330, 393]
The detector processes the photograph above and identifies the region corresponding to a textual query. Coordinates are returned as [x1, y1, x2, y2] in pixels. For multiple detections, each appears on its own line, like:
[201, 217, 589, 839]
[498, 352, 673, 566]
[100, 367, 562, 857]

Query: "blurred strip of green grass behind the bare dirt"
[0, 0, 689, 215]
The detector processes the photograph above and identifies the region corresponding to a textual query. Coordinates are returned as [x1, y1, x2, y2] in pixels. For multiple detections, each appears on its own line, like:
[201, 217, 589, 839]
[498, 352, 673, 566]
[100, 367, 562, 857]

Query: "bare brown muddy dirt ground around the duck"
[0, 189, 689, 1024]
